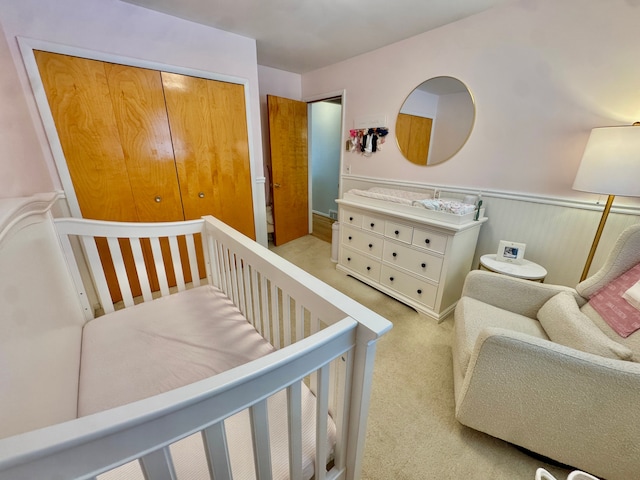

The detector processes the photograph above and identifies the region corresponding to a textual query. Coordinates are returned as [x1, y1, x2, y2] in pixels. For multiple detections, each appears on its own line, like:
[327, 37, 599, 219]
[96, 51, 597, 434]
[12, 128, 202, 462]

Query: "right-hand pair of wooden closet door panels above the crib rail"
[162, 72, 255, 239]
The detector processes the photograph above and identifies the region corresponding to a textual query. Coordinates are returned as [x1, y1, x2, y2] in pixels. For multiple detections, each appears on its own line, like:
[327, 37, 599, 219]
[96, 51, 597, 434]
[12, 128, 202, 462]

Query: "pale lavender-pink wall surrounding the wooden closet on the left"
[0, 0, 266, 244]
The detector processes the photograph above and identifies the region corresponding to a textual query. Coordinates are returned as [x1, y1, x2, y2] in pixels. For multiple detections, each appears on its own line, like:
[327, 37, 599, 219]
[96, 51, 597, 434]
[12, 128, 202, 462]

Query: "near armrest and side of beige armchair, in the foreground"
[456, 328, 640, 480]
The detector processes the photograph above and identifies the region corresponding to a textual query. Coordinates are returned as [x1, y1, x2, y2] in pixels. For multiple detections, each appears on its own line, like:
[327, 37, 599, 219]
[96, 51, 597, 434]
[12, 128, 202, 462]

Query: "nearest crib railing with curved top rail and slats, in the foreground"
[0, 319, 357, 480]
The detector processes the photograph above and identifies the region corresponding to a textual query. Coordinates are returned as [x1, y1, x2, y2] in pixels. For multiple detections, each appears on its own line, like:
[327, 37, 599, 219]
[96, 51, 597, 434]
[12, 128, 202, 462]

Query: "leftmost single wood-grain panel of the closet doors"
[34, 51, 138, 221]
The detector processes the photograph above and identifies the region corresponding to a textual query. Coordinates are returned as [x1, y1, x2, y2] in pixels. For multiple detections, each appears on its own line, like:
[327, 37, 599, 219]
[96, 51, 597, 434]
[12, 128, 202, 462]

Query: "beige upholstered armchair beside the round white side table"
[453, 224, 640, 480]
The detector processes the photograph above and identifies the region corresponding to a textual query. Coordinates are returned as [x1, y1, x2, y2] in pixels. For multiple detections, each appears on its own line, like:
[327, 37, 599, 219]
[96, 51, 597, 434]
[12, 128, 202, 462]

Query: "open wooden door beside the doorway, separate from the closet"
[267, 95, 309, 245]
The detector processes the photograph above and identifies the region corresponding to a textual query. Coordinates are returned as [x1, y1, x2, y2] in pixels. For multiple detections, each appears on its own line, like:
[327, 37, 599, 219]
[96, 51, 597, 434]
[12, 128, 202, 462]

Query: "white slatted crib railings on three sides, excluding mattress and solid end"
[0, 217, 391, 480]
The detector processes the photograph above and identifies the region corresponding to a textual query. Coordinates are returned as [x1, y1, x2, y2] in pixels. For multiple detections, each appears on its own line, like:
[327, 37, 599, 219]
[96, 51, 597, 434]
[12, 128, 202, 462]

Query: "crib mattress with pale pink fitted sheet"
[79, 285, 335, 480]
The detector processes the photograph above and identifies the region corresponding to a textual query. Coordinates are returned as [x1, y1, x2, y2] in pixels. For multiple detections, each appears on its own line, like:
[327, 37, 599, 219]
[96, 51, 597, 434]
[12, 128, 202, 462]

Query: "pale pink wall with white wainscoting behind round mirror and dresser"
[302, 0, 640, 285]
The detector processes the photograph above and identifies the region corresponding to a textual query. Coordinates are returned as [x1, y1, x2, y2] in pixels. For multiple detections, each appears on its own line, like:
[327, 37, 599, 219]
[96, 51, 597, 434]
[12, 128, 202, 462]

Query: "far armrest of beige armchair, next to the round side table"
[462, 270, 585, 319]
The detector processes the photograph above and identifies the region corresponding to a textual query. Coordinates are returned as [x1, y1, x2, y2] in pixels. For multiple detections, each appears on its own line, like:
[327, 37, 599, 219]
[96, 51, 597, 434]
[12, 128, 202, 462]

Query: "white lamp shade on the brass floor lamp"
[573, 126, 640, 197]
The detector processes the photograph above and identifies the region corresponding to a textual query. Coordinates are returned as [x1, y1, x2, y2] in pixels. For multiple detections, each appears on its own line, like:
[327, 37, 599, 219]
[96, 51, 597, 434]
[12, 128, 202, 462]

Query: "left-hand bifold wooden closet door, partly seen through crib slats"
[34, 51, 190, 301]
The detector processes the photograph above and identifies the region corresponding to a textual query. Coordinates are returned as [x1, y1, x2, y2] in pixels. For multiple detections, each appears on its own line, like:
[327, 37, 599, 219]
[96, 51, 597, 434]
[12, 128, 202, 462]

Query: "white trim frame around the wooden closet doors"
[17, 37, 267, 244]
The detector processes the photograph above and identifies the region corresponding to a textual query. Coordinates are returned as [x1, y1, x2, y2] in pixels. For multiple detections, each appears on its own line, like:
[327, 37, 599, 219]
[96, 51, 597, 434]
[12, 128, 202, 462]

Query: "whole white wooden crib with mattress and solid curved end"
[0, 194, 391, 480]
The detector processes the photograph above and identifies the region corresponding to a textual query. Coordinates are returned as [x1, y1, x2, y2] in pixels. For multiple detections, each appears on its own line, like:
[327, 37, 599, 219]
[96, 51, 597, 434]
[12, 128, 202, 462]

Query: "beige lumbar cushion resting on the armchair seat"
[538, 292, 633, 360]
